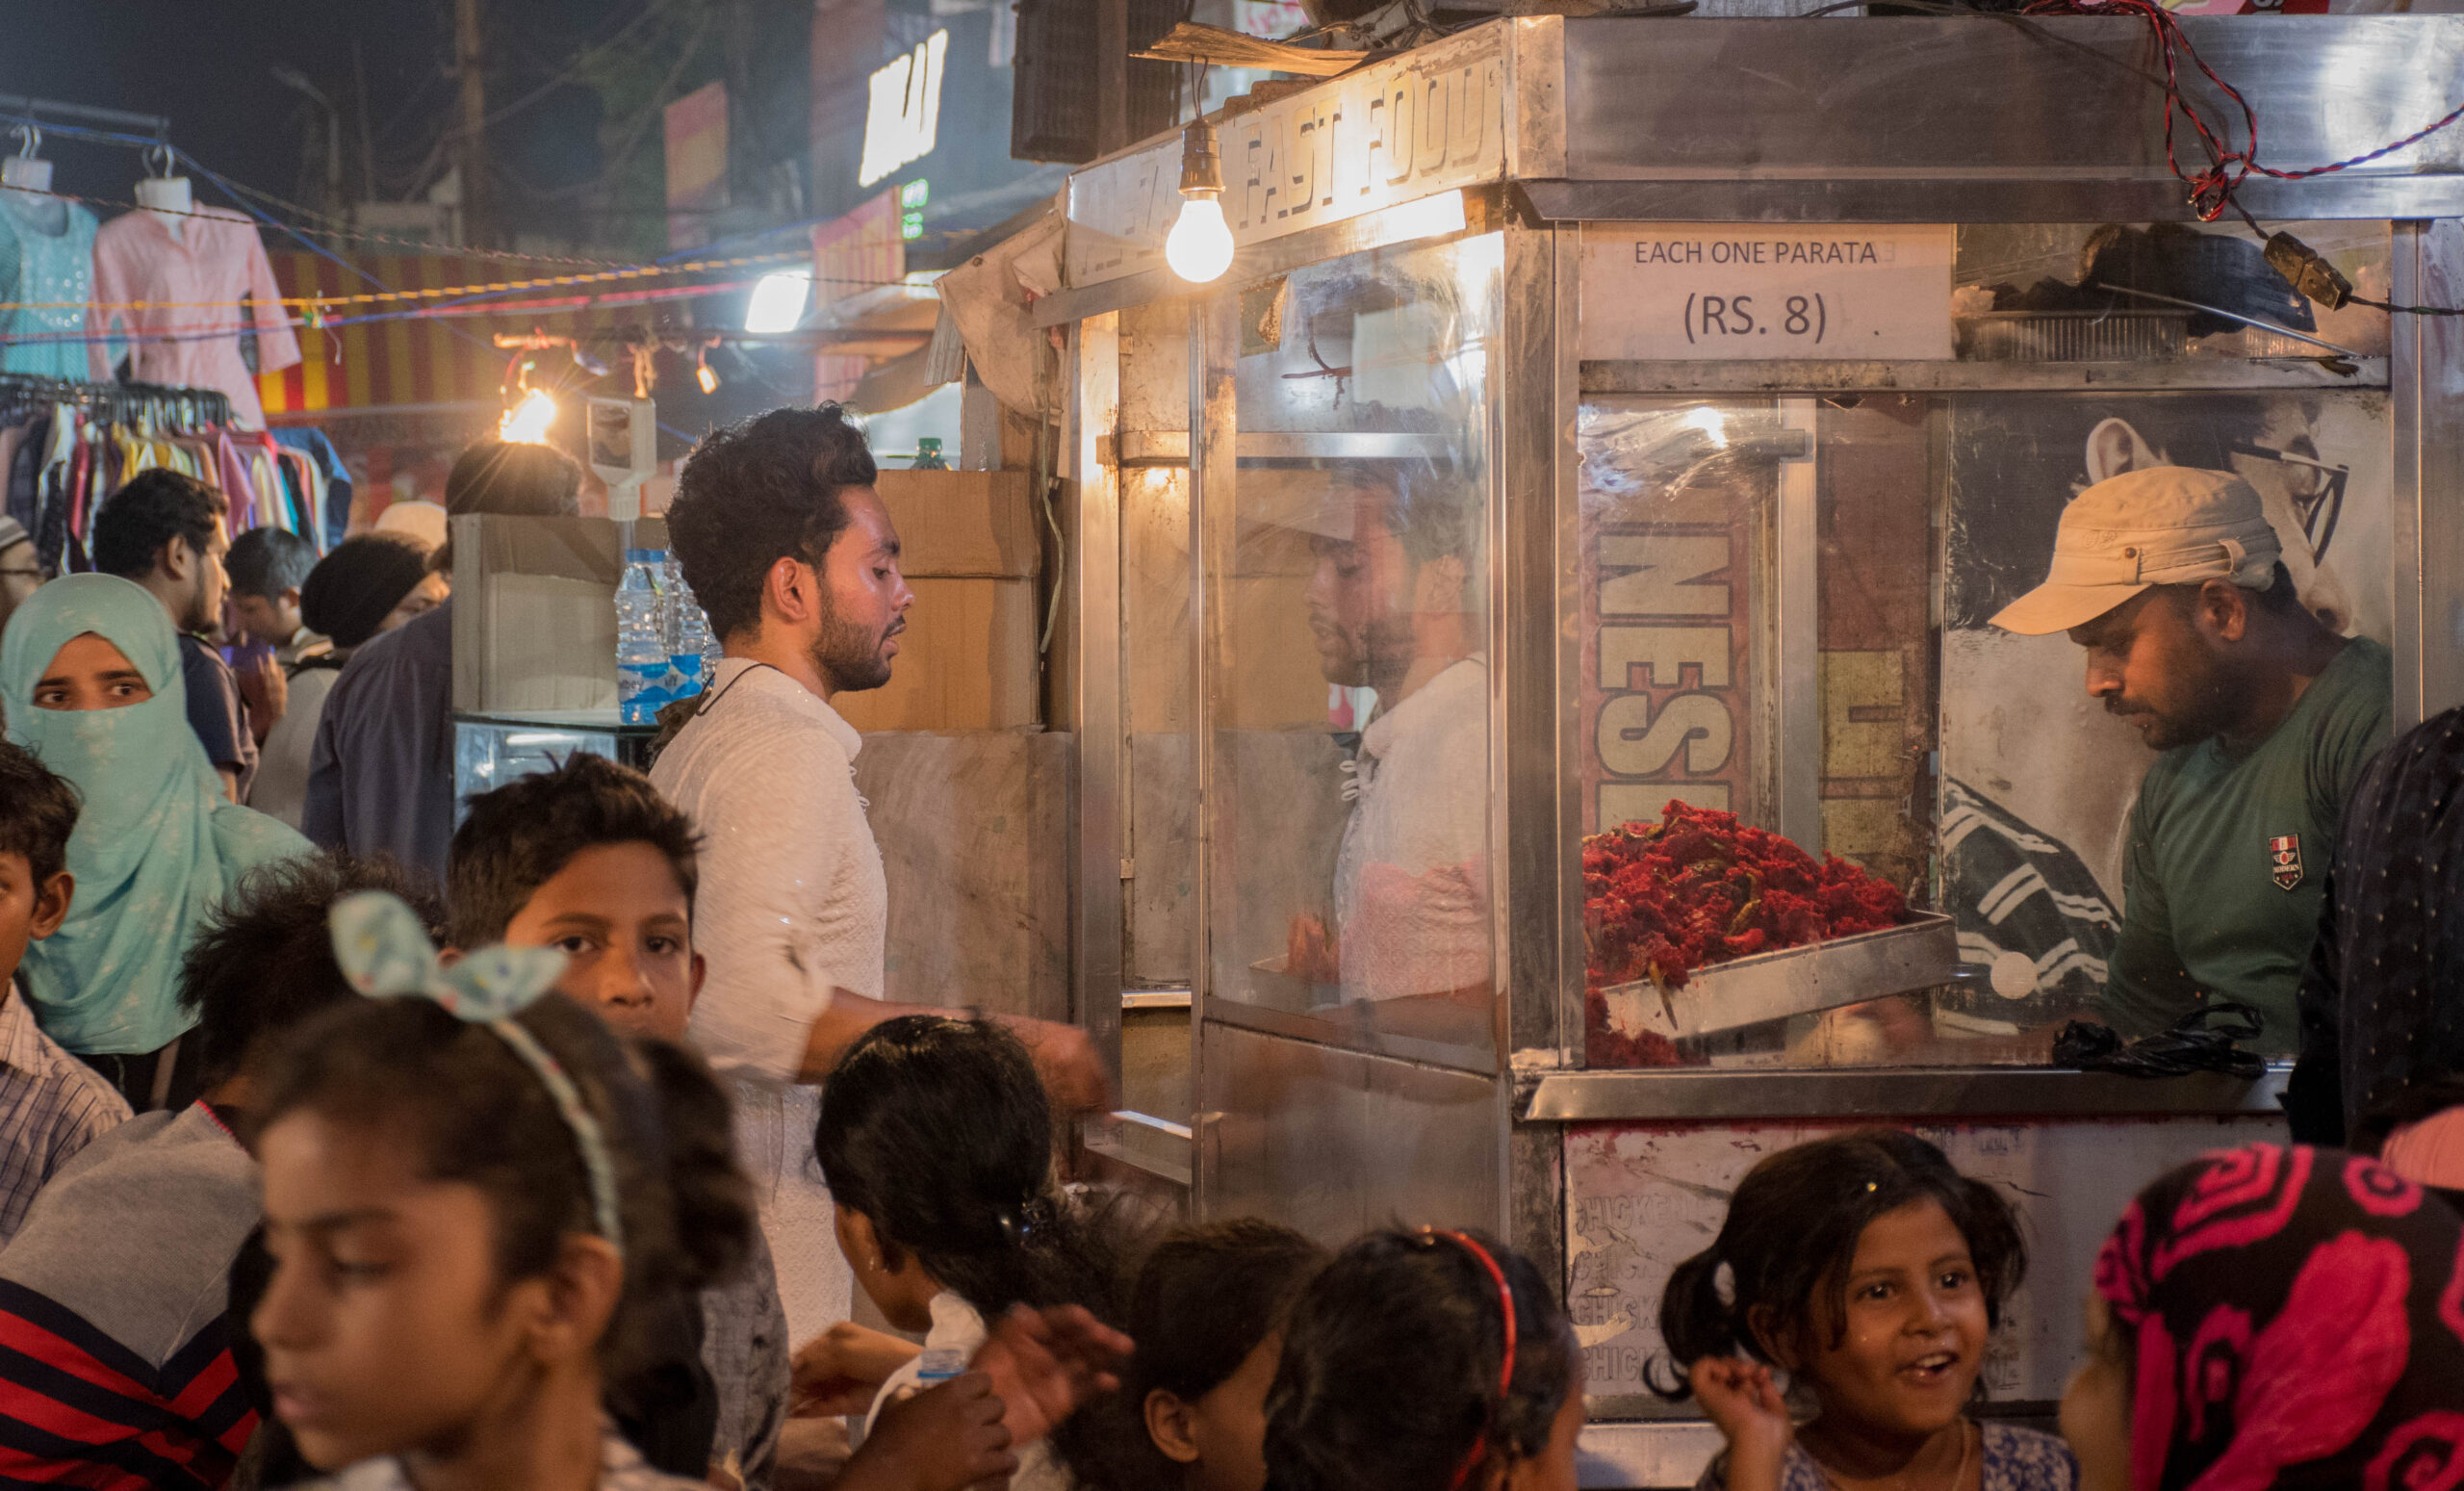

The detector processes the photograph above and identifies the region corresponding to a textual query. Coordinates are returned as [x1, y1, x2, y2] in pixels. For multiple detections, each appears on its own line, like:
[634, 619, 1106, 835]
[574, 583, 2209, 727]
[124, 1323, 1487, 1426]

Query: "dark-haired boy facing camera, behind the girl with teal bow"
[446, 754, 788, 1491]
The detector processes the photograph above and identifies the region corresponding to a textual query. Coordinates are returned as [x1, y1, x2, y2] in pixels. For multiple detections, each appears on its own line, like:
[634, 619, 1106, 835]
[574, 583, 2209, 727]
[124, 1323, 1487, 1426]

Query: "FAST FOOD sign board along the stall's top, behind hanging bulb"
[1066, 27, 1508, 286]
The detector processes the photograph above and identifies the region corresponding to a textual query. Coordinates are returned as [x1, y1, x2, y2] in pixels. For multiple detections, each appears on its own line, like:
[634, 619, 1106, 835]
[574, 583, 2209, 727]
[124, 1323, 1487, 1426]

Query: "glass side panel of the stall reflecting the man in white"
[1207, 234, 1501, 1069]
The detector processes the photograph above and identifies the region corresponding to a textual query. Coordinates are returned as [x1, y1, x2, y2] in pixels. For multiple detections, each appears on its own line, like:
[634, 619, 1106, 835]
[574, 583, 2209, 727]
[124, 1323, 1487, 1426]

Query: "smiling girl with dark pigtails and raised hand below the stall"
[1660, 1129, 2077, 1491]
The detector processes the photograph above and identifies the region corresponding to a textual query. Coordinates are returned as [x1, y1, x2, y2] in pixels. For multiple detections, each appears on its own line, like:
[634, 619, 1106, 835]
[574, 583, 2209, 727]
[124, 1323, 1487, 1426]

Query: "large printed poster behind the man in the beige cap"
[1935, 390, 2393, 1033]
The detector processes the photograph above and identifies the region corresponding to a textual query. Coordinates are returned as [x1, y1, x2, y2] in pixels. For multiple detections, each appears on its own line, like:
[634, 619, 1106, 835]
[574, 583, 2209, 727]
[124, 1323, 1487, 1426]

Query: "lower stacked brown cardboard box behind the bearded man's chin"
[831, 577, 1042, 730]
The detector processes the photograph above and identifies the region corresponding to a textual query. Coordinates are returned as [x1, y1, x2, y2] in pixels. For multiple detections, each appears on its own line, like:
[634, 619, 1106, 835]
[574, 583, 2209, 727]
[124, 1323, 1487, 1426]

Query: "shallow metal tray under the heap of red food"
[1599, 912, 1959, 1040]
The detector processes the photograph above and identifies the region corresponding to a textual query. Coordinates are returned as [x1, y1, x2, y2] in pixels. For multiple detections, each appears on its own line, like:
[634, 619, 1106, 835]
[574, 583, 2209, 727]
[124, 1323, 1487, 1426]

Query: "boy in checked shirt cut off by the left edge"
[0, 739, 128, 1245]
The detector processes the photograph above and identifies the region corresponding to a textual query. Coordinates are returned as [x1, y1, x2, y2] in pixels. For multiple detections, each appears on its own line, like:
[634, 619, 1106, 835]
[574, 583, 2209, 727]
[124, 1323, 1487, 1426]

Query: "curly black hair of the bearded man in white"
[668, 404, 877, 641]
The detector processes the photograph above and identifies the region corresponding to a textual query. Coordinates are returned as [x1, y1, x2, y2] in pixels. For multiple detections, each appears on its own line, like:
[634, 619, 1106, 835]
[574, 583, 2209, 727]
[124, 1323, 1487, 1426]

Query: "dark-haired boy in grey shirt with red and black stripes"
[0, 855, 441, 1491]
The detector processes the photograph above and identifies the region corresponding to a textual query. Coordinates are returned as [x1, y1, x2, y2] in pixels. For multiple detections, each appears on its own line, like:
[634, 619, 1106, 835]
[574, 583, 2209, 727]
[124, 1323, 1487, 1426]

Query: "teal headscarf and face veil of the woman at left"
[0, 575, 316, 1055]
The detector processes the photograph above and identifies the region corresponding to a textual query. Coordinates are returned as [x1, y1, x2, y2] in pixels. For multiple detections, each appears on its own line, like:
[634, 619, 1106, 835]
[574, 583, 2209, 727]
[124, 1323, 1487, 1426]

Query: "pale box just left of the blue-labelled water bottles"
[453, 515, 624, 714]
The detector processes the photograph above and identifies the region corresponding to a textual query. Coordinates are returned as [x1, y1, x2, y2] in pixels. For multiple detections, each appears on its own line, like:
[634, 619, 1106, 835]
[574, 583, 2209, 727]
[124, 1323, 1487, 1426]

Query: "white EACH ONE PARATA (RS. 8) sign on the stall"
[1582, 221, 1952, 362]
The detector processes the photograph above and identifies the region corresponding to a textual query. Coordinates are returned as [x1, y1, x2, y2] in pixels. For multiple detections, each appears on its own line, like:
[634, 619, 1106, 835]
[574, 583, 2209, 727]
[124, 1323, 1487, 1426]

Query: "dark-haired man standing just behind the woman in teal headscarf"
[93, 466, 259, 804]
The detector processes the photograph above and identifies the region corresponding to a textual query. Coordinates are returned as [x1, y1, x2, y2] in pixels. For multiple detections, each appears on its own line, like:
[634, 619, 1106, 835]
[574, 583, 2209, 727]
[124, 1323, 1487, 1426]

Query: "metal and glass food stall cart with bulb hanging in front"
[1028, 14, 2464, 1486]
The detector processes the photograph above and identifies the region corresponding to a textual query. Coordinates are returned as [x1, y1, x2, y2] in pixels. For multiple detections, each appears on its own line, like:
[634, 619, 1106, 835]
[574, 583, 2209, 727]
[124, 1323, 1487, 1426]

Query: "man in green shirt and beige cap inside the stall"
[1993, 466, 2395, 1055]
